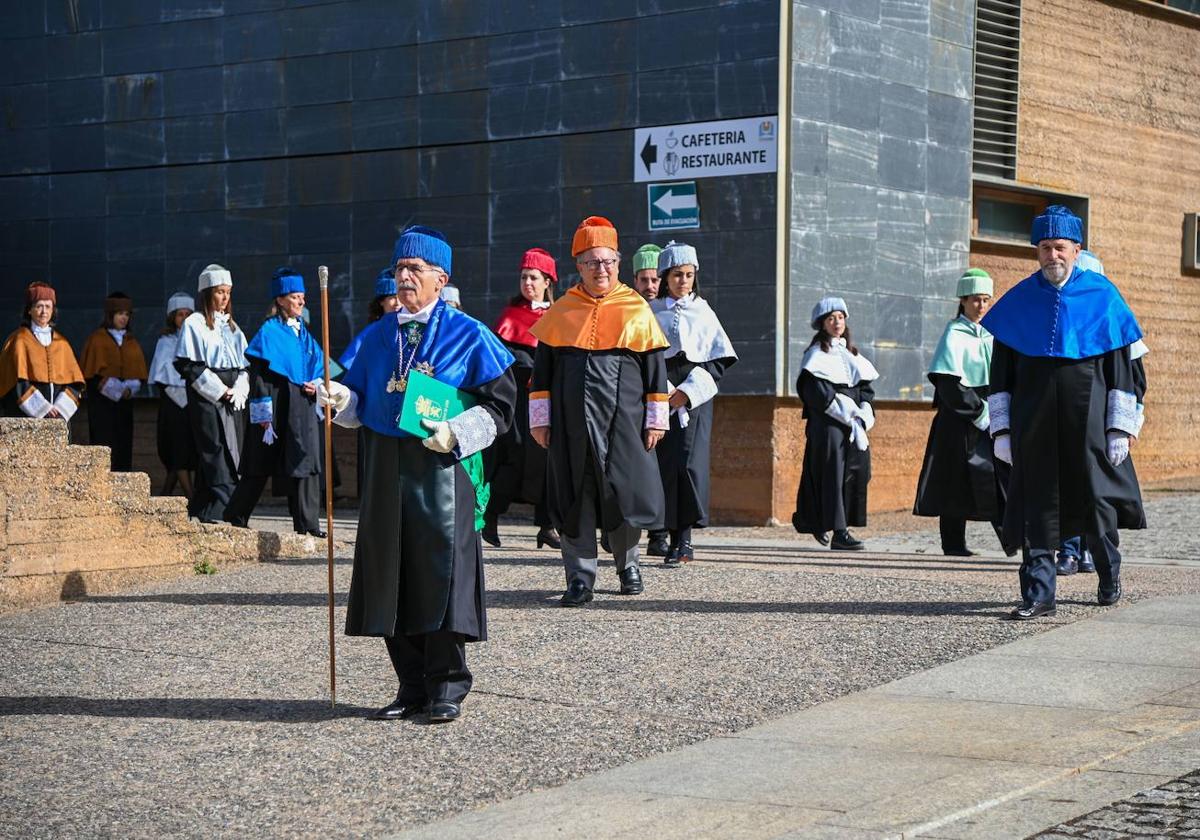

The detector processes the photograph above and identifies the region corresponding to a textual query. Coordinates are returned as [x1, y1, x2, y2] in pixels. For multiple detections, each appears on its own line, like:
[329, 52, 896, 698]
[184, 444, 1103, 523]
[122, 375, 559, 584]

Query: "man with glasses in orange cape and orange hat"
[529, 216, 668, 606]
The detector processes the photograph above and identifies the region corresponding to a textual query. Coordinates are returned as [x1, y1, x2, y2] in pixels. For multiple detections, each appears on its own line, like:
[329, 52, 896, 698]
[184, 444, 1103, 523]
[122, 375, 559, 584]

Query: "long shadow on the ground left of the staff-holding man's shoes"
[0, 696, 374, 724]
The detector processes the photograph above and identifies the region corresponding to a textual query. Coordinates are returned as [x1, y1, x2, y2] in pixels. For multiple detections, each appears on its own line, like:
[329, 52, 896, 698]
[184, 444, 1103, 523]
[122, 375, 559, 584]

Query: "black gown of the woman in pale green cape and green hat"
[912, 373, 1008, 522]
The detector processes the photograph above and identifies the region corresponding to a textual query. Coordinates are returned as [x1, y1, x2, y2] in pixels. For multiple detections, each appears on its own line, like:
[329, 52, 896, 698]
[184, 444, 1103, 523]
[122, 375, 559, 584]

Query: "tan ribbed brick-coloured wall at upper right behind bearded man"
[971, 0, 1200, 484]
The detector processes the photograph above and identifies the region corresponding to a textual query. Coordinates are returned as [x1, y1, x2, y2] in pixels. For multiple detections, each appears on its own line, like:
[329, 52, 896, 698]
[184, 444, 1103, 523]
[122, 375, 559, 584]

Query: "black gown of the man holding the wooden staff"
[346, 368, 516, 642]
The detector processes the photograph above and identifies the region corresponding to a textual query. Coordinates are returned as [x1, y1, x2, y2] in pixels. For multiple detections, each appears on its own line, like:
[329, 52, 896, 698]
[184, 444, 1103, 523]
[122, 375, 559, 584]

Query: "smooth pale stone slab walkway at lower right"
[398, 596, 1200, 840]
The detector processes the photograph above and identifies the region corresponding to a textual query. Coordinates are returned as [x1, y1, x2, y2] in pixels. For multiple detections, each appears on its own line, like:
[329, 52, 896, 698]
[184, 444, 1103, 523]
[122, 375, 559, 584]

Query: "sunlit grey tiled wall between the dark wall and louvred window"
[786, 0, 974, 400]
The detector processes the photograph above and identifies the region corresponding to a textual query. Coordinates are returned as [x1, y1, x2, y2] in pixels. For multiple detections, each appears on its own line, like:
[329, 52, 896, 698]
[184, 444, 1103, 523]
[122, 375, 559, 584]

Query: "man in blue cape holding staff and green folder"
[318, 226, 516, 722]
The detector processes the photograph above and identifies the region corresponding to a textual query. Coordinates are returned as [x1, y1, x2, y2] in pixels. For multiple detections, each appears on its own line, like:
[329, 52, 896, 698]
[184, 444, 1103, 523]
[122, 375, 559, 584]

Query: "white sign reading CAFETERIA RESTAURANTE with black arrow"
[634, 116, 779, 181]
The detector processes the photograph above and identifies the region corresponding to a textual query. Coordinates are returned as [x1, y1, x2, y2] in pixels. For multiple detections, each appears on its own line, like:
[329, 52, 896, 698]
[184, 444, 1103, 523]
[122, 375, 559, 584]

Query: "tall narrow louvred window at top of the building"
[972, 0, 1021, 180]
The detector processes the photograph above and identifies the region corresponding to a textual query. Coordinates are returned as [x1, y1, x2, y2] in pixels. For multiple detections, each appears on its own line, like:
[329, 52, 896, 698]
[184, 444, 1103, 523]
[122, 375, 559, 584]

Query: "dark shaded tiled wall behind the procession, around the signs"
[0, 0, 779, 392]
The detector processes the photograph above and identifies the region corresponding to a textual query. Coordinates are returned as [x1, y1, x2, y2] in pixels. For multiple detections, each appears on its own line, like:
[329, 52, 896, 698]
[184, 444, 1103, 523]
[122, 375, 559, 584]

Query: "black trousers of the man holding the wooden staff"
[383, 630, 473, 703]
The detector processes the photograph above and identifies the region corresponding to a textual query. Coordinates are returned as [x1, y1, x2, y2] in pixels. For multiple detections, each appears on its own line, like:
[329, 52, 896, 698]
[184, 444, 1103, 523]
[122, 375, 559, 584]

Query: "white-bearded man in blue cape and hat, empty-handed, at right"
[983, 205, 1146, 620]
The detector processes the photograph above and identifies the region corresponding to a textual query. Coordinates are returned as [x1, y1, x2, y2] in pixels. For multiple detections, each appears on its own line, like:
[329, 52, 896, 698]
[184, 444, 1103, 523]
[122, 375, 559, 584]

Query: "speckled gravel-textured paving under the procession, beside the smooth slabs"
[0, 494, 1200, 836]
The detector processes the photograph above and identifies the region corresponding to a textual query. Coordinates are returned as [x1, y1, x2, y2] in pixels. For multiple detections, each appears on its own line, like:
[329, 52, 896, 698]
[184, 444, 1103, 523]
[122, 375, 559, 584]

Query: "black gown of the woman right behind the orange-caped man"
[654, 353, 734, 530]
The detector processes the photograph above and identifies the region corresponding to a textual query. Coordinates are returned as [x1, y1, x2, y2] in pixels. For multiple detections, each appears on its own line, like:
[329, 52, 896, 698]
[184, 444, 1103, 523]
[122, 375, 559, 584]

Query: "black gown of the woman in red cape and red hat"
[484, 341, 550, 528]
